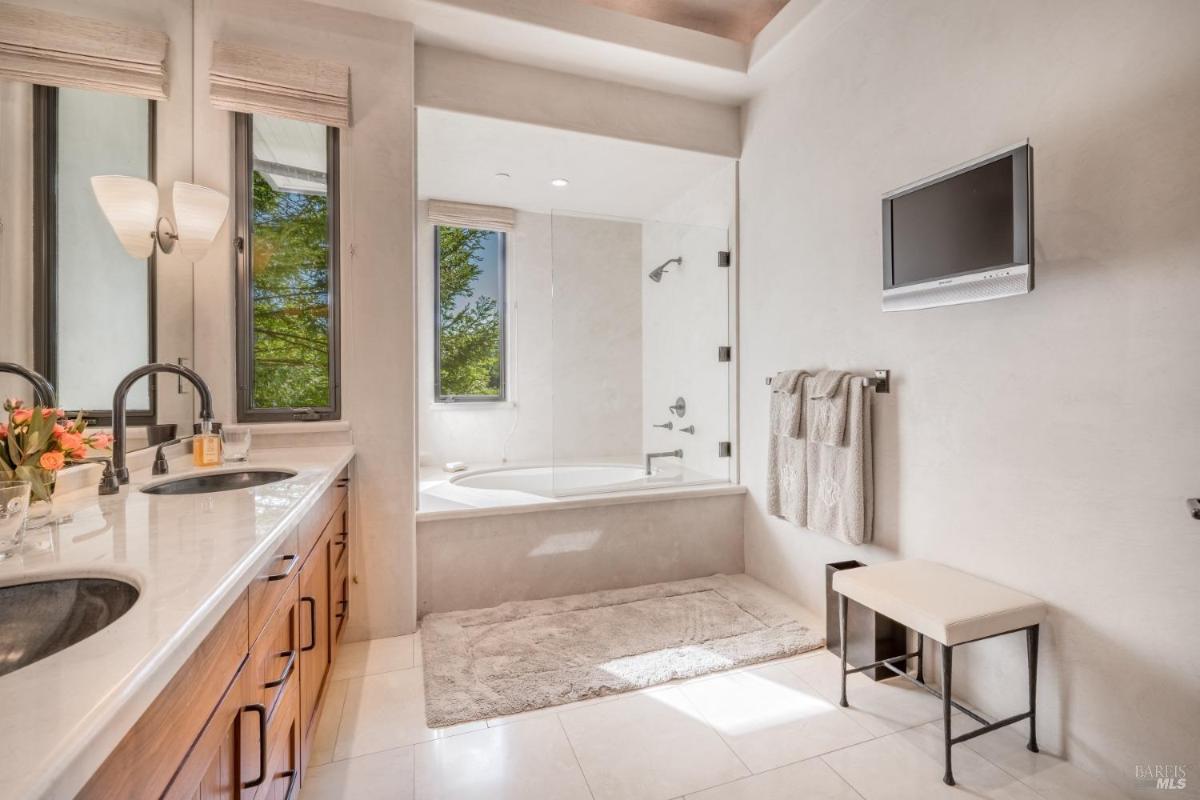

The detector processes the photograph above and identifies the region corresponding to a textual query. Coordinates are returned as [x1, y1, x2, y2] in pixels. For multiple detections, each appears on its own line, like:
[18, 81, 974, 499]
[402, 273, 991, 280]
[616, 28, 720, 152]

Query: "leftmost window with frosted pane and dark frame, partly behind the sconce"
[34, 86, 156, 425]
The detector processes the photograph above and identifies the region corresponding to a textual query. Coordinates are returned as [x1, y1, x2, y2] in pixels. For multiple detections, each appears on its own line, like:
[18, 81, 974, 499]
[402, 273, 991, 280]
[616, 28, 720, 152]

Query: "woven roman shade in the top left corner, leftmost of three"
[0, 2, 168, 100]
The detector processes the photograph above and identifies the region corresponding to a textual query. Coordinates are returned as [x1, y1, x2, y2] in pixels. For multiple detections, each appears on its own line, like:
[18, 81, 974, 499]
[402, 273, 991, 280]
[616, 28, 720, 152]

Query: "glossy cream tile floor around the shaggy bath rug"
[300, 592, 1124, 800]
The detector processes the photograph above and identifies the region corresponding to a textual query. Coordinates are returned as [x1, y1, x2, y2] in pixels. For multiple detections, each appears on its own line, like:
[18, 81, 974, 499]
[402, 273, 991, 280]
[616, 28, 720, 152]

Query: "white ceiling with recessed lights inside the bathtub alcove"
[416, 108, 733, 219]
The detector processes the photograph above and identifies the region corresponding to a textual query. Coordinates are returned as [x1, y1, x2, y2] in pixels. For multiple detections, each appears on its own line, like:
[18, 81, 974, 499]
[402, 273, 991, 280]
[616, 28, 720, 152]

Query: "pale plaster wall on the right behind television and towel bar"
[740, 0, 1200, 796]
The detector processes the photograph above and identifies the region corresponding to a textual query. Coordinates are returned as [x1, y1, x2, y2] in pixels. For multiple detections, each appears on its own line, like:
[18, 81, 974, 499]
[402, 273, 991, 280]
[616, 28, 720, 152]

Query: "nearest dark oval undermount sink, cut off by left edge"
[0, 578, 138, 675]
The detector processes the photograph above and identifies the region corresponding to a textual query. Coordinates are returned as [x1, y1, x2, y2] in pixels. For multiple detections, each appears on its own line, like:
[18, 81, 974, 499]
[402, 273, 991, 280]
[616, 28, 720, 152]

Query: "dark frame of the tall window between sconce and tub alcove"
[233, 112, 342, 422]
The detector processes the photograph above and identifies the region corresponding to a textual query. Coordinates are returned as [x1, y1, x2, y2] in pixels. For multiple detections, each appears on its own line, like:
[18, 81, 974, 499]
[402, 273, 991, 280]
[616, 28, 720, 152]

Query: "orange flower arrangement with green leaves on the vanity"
[0, 397, 113, 501]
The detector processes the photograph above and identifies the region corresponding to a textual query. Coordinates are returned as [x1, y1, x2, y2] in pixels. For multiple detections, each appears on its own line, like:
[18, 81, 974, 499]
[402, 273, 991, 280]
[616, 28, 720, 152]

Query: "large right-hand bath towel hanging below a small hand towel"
[804, 377, 875, 545]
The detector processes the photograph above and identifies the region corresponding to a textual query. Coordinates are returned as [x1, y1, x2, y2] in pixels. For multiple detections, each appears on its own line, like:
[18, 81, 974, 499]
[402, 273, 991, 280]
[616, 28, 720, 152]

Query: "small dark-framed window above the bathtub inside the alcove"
[434, 225, 505, 403]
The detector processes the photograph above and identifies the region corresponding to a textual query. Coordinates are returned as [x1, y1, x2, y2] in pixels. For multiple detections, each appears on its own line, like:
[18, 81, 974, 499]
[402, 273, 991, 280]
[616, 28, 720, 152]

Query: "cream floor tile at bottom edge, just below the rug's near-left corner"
[415, 716, 592, 800]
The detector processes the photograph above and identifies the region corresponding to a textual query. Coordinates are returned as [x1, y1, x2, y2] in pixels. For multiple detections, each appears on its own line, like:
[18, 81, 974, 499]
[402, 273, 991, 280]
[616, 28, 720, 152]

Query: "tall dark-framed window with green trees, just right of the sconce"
[235, 114, 341, 422]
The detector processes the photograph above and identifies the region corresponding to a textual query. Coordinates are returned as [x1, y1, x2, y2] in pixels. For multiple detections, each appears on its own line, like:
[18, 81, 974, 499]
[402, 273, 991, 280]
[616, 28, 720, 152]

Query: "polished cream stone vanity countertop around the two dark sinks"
[0, 445, 354, 800]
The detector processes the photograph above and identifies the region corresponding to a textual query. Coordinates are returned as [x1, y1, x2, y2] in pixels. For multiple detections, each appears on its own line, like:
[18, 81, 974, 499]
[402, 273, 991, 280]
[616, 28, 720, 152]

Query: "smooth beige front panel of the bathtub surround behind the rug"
[416, 485, 745, 615]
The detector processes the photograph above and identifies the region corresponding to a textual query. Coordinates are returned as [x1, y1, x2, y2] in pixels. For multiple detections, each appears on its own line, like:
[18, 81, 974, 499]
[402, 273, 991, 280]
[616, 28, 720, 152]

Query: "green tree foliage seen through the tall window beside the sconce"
[251, 172, 332, 408]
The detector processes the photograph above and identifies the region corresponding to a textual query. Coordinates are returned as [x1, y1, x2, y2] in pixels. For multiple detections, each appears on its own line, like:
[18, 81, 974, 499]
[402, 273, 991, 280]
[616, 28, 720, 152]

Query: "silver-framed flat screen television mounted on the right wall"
[883, 144, 1033, 311]
